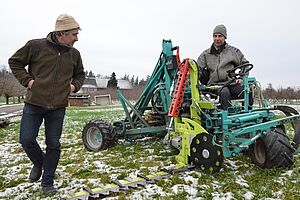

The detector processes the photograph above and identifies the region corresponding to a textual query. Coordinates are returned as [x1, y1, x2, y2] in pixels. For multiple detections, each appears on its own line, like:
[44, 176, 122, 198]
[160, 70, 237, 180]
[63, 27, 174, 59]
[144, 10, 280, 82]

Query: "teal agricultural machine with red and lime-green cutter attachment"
[65, 40, 300, 198]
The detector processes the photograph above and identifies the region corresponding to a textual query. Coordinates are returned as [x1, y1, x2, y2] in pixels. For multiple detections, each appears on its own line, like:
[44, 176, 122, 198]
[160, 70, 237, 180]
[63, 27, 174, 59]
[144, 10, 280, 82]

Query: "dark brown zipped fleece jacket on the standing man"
[8, 33, 85, 110]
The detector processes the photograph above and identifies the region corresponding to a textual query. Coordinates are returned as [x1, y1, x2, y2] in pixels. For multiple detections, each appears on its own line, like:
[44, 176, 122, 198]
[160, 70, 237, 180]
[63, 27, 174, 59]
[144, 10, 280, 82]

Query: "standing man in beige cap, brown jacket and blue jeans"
[8, 14, 85, 194]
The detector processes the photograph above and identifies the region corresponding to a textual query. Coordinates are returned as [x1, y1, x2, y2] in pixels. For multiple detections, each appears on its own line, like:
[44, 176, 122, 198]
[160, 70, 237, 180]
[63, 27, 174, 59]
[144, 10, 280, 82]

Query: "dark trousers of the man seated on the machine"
[219, 84, 253, 110]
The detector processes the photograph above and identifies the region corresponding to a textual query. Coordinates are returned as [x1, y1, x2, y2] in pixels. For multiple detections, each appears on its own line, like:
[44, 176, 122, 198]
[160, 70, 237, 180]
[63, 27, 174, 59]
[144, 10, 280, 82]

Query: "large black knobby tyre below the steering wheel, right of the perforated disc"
[249, 128, 293, 168]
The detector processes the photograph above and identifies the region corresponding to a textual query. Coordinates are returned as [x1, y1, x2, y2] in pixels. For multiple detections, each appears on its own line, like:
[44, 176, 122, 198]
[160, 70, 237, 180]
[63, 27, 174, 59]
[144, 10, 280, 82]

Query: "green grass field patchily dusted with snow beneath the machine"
[0, 107, 300, 200]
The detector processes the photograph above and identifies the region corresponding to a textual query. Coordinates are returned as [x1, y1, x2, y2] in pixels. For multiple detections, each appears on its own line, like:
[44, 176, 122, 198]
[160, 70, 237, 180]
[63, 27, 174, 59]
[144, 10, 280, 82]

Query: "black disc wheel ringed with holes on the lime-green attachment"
[190, 133, 224, 174]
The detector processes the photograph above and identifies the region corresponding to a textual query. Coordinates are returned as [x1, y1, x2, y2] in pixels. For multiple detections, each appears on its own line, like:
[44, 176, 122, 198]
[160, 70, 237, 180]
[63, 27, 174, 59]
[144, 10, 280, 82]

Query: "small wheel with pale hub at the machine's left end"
[82, 120, 116, 151]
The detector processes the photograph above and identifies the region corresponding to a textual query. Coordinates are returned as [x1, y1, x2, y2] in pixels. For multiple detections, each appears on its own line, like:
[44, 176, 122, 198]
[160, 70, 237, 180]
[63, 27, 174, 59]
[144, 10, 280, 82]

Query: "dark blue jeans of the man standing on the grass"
[20, 103, 66, 187]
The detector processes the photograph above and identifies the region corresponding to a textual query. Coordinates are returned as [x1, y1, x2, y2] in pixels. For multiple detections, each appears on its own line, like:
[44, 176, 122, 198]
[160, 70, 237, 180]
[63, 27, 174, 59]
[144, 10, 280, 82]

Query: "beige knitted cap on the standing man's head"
[55, 14, 80, 31]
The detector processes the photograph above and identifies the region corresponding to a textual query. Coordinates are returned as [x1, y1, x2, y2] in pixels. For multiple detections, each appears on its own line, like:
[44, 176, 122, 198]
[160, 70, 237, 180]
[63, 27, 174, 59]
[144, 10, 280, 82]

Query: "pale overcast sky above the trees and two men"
[0, 0, 300, 88]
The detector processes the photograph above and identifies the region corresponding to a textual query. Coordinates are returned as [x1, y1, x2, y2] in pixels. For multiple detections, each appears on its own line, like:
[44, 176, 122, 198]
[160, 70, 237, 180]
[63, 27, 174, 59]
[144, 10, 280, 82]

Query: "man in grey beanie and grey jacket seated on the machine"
[197, 25, 253, 110]
